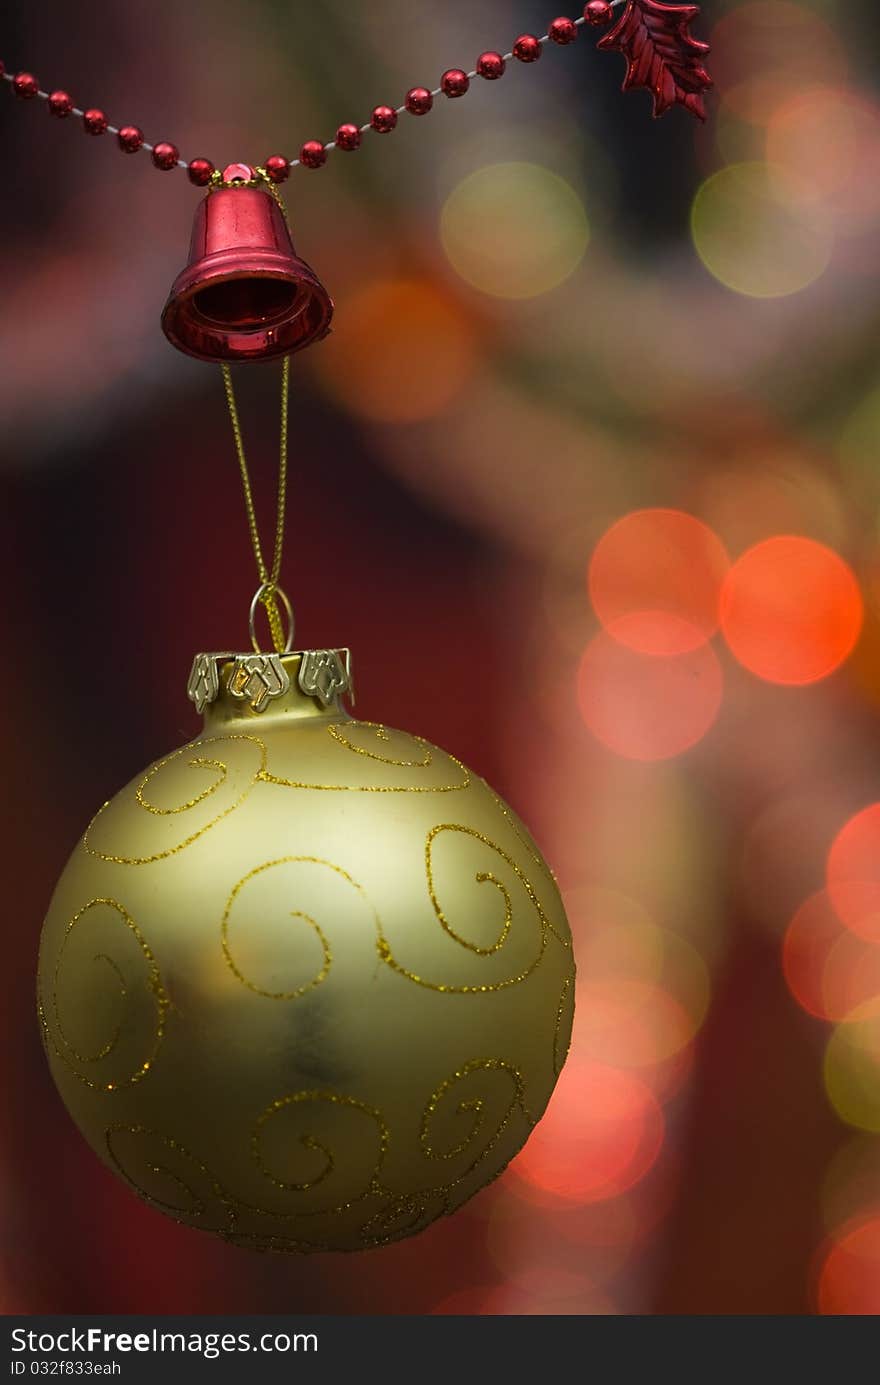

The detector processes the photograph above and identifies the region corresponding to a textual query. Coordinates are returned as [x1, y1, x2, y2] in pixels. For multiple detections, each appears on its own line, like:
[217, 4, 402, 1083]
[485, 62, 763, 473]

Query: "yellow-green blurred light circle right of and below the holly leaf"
[690, 162, 834, 298]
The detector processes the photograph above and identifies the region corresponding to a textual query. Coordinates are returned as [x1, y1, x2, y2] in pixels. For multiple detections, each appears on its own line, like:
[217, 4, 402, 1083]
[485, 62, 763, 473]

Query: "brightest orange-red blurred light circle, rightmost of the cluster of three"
[721, 535, 863, 684]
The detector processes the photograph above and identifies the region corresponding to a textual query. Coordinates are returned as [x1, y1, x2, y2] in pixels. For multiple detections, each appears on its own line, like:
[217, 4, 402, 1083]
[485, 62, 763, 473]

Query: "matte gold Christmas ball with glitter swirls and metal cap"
[39, 651, 574, 1251]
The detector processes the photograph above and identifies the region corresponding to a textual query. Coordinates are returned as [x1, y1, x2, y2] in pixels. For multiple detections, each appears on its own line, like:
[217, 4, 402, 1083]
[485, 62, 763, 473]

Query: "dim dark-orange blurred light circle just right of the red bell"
[315, 278, 478, 424]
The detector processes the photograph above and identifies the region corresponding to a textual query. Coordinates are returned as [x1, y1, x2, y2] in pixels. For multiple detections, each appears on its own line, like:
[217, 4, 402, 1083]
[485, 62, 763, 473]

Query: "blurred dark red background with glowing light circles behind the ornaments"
[0, 0, 880, 1314]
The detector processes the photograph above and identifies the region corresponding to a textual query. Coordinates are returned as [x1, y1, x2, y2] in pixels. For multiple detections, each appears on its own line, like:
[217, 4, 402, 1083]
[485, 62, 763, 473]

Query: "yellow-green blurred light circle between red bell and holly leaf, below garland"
[441, 162, 590, 298]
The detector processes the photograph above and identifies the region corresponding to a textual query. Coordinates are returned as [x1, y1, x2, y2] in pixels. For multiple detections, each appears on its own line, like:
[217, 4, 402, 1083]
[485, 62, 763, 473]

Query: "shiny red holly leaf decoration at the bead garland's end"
[597, 0, 712, 120]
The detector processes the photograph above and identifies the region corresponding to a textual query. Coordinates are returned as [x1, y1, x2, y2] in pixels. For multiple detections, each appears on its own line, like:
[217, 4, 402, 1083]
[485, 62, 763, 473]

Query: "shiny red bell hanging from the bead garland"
[162, 163, 333, 361]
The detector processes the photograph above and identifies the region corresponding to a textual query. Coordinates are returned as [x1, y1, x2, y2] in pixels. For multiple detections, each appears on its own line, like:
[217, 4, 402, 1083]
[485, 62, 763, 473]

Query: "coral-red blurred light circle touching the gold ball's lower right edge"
[510, 1054, 665, 1202]
